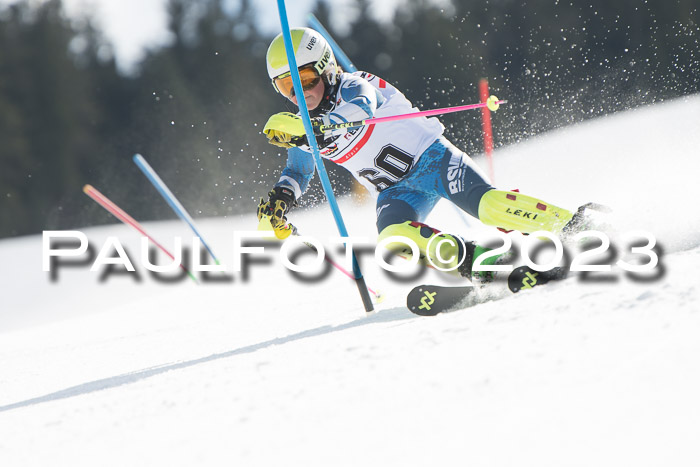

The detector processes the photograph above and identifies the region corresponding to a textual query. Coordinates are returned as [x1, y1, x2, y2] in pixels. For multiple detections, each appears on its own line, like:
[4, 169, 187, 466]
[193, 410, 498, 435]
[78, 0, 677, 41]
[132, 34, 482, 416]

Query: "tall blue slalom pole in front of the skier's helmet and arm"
[277, 0, 374, 312]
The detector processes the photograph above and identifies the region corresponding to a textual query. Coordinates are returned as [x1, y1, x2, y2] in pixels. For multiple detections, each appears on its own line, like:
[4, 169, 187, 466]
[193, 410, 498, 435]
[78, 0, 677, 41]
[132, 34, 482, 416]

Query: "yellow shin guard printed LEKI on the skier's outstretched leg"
[479, 190, 573, 233]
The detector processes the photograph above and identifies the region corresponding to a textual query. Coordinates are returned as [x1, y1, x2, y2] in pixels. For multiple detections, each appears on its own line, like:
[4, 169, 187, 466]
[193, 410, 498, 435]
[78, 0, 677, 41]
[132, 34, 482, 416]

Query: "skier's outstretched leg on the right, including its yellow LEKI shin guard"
[433, 138, 573, 233]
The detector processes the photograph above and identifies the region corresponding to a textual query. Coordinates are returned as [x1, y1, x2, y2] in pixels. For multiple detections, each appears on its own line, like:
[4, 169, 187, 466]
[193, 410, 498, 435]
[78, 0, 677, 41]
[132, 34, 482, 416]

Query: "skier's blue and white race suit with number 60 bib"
[277, 71, 493, 232]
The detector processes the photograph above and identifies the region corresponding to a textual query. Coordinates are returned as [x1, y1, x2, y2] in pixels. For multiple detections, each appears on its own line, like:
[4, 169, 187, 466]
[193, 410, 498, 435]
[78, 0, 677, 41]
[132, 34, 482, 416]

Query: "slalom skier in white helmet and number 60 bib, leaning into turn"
[257, 28, 578, 279]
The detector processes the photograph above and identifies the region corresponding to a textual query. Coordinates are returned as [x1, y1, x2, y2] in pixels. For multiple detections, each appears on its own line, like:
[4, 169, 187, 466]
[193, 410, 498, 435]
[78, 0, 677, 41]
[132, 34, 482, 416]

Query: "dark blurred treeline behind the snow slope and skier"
[0, 0, 700, 237]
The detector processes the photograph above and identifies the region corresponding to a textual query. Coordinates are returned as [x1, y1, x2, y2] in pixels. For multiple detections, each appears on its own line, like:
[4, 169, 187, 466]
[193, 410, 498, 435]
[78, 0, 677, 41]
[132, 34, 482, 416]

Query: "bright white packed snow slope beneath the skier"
[0, 96, 700, 467]
